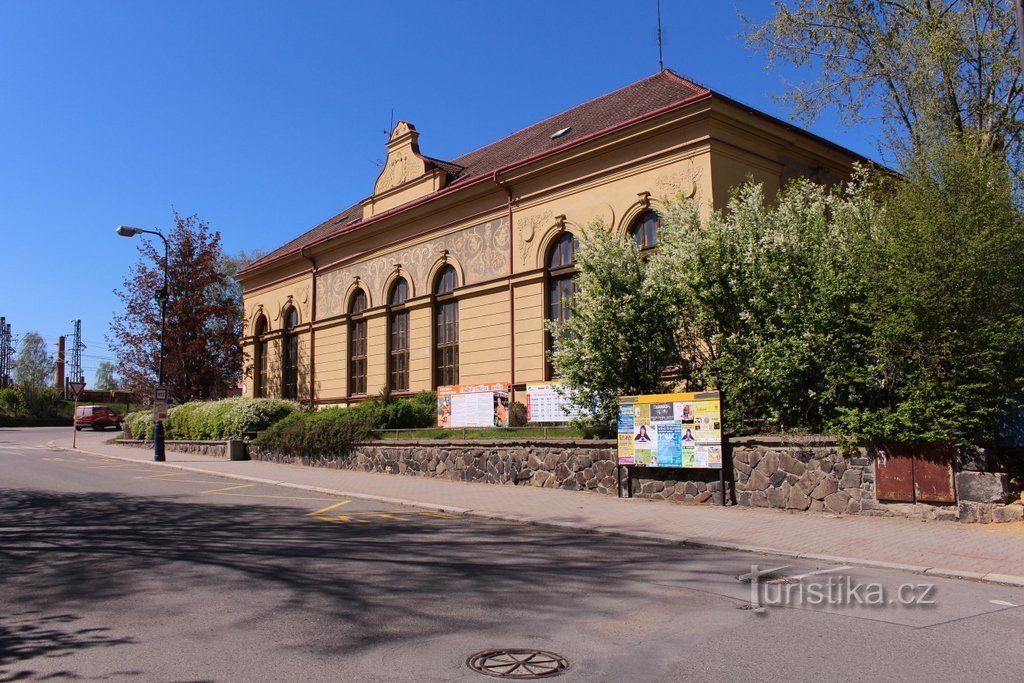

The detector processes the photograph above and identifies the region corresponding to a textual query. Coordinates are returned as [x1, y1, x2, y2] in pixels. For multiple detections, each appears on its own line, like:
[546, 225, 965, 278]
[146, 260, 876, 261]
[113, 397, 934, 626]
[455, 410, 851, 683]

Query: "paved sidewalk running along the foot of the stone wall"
[58, 437, 1024, 586]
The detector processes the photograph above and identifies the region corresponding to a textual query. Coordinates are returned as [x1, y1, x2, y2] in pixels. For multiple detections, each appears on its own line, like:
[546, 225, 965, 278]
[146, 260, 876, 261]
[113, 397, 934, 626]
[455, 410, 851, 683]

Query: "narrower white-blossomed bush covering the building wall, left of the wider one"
[549, 223, 678, 427]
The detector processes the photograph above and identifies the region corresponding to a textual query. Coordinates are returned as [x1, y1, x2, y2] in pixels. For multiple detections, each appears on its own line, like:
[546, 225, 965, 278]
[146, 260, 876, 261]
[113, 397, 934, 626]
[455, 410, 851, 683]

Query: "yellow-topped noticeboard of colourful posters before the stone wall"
[617, 391, 722, 469]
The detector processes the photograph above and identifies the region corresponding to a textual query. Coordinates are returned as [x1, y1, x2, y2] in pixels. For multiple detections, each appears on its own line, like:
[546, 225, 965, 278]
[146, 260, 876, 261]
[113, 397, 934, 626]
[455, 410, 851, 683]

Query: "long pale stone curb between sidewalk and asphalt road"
[61, 445, 1024, 588]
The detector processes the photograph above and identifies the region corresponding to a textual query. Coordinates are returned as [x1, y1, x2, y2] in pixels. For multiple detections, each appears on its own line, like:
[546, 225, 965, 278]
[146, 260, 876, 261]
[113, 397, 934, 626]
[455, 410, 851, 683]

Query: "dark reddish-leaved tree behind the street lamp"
[108, 212, 242, 402]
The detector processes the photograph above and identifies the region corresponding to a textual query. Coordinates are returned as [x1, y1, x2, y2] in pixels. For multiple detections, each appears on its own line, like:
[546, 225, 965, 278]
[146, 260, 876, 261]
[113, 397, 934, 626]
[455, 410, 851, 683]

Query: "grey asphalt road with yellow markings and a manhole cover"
[0, 429, 1024, 682]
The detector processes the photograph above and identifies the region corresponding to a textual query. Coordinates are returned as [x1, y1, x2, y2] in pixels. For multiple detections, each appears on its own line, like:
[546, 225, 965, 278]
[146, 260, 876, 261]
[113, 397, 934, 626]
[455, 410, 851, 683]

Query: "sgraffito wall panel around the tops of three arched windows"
[316, 218, 511, 319]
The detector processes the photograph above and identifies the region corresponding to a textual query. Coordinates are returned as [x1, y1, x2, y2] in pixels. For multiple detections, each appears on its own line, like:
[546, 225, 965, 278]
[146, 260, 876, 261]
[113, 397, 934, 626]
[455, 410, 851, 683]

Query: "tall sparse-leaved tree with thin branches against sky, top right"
[746, 0, 1024, 169]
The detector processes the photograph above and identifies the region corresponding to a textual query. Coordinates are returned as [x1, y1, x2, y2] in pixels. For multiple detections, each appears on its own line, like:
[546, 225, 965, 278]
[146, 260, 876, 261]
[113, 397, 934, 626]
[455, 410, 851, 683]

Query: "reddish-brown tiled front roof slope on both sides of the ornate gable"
[242, 70, 711, 272]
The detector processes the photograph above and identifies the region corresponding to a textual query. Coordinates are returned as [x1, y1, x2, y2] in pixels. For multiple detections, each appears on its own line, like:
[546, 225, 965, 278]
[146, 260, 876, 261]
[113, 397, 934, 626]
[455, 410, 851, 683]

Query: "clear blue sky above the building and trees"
[0, 0, 878, 384]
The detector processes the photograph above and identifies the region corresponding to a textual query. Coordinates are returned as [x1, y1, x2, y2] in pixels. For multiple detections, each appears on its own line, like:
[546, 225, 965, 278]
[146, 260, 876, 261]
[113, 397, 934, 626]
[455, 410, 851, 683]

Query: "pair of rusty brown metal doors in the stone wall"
[874, 443, 956, 503]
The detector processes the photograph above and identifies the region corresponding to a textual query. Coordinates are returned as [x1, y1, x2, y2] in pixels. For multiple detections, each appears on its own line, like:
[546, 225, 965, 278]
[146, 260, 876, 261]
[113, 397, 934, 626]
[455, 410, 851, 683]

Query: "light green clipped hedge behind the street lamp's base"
[124, 398, 301, 441]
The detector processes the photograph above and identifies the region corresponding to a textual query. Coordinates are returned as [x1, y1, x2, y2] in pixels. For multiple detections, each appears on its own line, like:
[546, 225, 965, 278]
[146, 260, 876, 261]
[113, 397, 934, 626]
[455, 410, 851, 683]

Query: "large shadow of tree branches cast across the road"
[0, 489, 734, 660]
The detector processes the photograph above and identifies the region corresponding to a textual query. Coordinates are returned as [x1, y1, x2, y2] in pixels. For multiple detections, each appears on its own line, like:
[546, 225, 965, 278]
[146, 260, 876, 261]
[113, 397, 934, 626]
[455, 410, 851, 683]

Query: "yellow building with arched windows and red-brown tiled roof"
[239, 71, 864, 404]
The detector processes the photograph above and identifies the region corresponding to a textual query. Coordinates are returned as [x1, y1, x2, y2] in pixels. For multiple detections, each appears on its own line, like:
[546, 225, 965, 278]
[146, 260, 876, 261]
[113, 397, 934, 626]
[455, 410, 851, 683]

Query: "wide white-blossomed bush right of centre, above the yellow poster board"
[651, 180, 878, 431]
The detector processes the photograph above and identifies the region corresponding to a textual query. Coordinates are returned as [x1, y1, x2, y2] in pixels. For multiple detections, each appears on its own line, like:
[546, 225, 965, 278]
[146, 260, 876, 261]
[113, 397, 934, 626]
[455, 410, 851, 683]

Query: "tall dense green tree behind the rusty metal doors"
[845, 142, 1024, 444]
